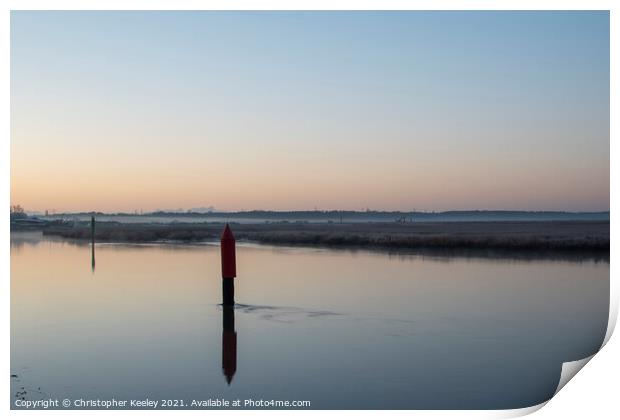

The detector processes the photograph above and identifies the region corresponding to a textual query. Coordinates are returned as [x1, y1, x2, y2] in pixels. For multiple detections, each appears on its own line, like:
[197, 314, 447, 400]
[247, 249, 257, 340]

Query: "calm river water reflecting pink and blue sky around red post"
[11, 233, 609, 409]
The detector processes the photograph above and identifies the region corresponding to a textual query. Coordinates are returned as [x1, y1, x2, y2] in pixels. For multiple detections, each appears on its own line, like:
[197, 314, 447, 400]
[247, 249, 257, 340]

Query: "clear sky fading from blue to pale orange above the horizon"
[10, 11, 610, 212]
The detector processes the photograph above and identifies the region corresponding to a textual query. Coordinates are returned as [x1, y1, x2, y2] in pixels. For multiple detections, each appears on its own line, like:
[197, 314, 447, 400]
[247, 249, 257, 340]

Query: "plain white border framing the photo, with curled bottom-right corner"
[0, 0, 620, 420]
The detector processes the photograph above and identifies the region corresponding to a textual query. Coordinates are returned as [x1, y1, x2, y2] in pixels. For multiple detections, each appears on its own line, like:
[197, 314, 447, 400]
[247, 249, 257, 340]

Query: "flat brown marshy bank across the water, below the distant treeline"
[30, 221, 609, 255]
